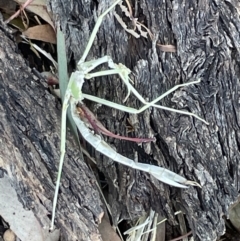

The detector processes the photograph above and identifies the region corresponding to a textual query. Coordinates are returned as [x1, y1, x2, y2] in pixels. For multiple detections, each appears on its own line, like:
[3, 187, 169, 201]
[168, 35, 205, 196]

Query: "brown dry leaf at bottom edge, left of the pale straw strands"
[98, 216, 121, 241]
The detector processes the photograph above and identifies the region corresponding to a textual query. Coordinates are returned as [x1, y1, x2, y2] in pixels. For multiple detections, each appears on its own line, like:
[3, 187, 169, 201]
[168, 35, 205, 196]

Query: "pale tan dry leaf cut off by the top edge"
[15, 0, 55, 30]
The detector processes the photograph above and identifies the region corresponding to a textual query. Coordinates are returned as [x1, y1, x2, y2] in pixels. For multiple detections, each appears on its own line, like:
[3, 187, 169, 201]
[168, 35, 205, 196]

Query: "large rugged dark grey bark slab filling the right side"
[50, 0, 240, 240]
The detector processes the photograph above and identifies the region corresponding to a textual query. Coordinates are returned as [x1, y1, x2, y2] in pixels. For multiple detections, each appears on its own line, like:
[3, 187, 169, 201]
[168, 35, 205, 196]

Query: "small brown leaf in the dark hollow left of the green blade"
[23, 24, 57, 44]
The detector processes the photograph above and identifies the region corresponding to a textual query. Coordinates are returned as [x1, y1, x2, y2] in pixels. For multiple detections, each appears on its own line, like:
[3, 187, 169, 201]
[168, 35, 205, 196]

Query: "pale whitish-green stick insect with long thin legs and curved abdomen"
[50, 0, 208, 230]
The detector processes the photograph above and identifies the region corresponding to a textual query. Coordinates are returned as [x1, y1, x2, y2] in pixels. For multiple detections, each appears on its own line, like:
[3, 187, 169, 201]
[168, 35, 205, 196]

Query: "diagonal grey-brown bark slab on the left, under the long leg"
[0, 29, 103, 241]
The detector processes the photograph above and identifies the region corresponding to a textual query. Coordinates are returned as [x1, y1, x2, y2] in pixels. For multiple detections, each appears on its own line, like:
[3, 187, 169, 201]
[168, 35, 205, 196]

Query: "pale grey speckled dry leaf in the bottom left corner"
[0, 176, 59, 241]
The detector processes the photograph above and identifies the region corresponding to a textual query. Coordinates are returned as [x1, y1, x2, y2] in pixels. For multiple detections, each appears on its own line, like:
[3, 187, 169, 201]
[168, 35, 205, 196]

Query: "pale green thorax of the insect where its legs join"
[68, 71, 84, 101]
